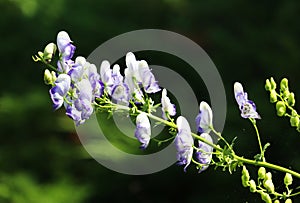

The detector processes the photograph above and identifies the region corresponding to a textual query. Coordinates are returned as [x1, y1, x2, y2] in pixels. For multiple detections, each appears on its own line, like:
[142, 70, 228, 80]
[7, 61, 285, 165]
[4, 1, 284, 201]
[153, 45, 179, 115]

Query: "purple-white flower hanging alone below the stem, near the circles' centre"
[135, 112, 151, 149]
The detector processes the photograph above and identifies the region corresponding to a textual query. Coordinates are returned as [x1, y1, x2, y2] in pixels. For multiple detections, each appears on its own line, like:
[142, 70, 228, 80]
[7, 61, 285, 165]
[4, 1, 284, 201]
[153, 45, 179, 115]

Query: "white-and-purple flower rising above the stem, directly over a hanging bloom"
[196, 101, 213, 133]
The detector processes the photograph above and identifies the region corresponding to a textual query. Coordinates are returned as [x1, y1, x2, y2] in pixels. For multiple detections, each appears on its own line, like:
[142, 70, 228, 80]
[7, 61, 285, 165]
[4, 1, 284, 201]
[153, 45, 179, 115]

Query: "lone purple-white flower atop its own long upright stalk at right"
[234, 82, 260, 119]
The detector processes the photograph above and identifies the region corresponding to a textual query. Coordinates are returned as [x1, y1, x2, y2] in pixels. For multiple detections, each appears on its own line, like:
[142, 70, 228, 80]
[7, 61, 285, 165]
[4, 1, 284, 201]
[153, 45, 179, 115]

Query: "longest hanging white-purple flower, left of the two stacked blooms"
[175, 116, 194, 171]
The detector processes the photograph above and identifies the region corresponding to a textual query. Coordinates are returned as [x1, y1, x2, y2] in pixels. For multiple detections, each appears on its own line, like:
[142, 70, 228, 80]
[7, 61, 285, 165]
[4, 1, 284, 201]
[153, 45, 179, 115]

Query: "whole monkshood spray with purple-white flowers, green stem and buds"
[32, 31, 300, 203]
